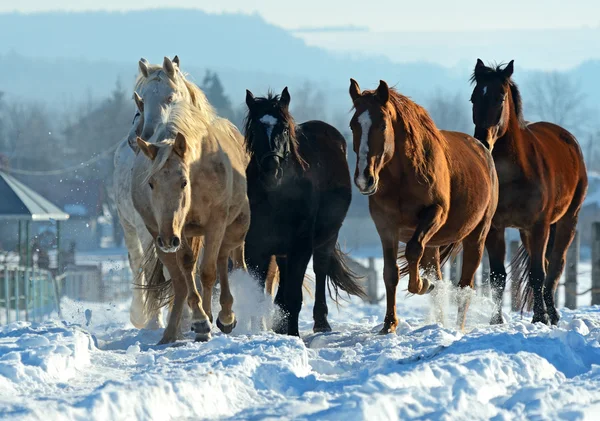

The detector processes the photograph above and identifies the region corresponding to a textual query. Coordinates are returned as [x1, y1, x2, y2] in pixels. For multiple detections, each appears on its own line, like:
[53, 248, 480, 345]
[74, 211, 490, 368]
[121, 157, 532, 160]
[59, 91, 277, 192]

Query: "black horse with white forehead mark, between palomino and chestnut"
[245, 87, 364, 336]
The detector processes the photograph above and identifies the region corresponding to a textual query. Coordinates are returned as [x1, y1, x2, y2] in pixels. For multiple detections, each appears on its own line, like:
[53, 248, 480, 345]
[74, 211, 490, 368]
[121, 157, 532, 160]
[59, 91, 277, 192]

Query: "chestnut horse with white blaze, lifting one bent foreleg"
[350, 79, 498, 333]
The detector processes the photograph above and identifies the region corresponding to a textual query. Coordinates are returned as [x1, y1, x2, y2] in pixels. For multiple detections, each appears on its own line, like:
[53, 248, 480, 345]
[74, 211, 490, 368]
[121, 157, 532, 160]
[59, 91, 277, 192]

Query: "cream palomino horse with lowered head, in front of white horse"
[132, 102, 250, 344]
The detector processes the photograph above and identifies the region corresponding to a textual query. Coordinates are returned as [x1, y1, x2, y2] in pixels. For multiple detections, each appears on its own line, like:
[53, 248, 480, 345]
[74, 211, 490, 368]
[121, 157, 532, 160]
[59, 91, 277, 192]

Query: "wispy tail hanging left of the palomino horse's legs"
[135, 242, 173, 316]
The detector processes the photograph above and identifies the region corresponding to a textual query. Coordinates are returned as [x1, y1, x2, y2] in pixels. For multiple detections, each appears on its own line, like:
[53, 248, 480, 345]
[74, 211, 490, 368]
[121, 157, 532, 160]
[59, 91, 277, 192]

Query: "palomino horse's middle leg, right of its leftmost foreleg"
[177, 236, 212, 341]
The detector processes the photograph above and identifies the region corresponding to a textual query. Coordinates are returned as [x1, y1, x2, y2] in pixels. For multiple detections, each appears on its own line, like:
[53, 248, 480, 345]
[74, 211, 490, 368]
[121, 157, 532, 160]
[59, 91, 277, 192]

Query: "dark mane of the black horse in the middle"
[244, 91, 308, 169]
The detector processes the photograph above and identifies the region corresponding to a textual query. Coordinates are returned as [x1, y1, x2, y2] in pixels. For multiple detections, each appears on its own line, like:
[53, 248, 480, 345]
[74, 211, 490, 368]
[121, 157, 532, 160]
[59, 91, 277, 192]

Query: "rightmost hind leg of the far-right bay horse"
[544, 213, 578, 325]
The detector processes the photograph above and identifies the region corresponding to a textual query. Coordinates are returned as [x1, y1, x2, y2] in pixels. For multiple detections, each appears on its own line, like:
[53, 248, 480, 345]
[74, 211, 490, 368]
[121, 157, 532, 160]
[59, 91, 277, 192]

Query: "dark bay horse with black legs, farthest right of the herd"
[471, 59, 588, 325]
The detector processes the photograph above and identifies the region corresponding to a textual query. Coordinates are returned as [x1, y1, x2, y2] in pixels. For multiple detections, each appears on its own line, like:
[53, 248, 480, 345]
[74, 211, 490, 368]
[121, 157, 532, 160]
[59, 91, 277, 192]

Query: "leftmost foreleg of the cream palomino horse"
[157, 250, 188, 345]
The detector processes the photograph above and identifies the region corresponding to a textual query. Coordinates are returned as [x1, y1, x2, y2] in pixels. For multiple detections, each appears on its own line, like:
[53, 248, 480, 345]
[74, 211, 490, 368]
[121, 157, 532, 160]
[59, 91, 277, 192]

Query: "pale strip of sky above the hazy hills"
[0, 0, 600, 31]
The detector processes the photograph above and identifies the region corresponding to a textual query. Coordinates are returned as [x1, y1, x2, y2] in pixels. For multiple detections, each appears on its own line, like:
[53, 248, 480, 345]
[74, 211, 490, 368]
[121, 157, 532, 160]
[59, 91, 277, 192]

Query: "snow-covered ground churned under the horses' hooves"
[0, 264, 600, 421]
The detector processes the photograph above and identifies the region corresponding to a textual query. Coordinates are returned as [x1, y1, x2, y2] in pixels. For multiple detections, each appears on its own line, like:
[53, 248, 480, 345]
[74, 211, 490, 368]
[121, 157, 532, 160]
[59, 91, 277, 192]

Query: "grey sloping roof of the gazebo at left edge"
[0, 171, 69, 221]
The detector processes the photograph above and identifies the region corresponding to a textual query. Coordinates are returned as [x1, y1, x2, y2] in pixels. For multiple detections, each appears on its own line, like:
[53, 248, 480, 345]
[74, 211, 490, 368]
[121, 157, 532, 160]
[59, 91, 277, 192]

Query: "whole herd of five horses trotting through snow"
[115, 56, 587, 343]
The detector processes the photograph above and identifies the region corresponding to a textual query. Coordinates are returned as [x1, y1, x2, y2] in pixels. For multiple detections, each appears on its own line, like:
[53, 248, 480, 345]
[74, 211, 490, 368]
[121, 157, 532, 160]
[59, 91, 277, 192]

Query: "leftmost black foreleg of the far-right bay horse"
[485, 226, 506, 325]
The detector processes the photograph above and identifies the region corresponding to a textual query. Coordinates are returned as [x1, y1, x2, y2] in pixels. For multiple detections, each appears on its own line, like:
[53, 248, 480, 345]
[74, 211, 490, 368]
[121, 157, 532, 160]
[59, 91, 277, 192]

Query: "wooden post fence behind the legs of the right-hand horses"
[350, 222, 600, 311]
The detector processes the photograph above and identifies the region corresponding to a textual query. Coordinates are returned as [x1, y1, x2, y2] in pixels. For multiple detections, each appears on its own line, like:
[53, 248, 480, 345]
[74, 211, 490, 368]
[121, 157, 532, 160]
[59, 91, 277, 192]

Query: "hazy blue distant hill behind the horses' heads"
[0, 9, 600, 124]
